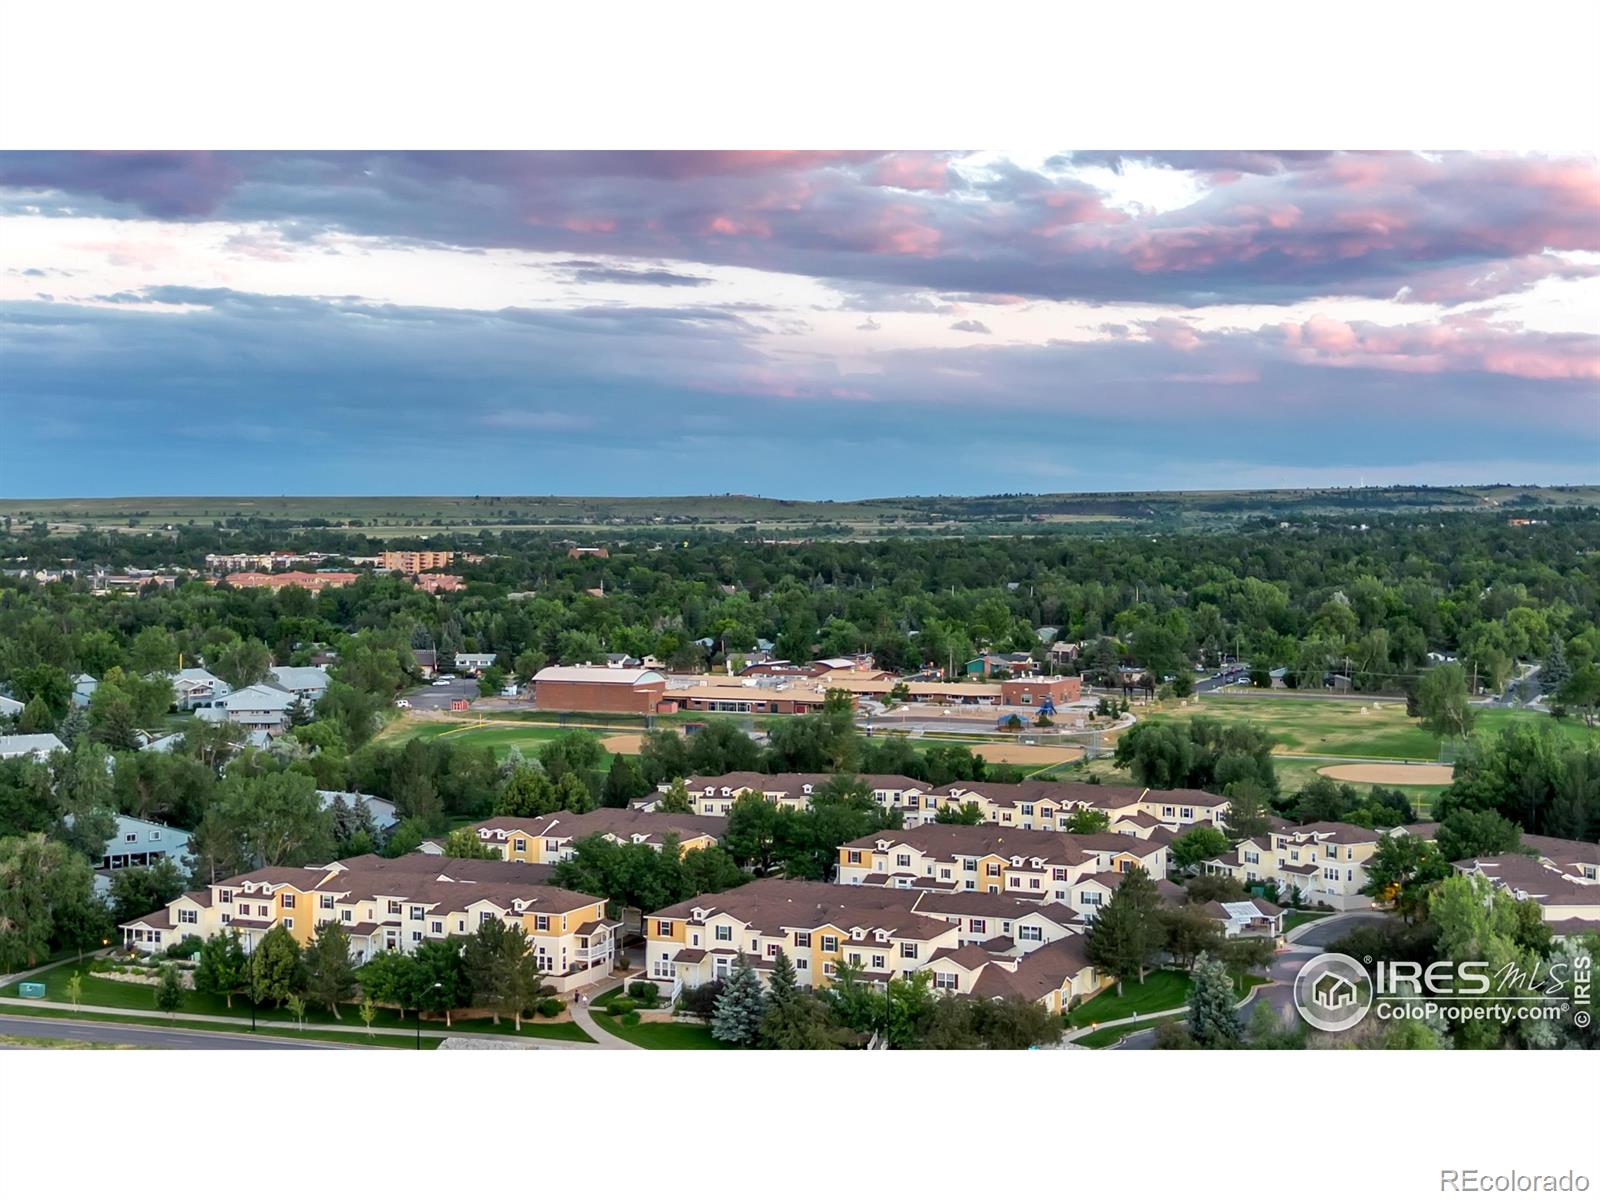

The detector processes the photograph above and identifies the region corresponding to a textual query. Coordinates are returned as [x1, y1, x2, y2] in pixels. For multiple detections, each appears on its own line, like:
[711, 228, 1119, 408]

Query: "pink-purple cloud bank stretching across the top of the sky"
[0, 150, 1600, 306]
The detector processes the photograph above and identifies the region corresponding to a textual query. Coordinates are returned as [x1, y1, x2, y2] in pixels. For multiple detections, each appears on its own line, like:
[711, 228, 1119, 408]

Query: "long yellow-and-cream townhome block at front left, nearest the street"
[122, 854, 621, 994]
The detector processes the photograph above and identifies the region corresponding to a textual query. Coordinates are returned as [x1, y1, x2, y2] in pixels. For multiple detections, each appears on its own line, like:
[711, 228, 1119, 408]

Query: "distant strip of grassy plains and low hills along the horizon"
[0, 486, 1600, 538]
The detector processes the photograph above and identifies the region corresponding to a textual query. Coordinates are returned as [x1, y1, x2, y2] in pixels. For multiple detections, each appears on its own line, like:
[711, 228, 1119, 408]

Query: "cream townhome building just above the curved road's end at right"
[1202, 821, 1388, 912]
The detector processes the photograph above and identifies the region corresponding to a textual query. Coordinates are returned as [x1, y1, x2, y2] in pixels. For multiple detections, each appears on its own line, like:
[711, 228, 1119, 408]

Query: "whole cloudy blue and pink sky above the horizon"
[0, 150, 1600, 499]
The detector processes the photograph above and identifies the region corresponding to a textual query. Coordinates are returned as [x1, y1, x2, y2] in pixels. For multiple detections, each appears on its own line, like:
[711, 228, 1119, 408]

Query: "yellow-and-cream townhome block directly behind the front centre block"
[838, 824, 1166, 902]
